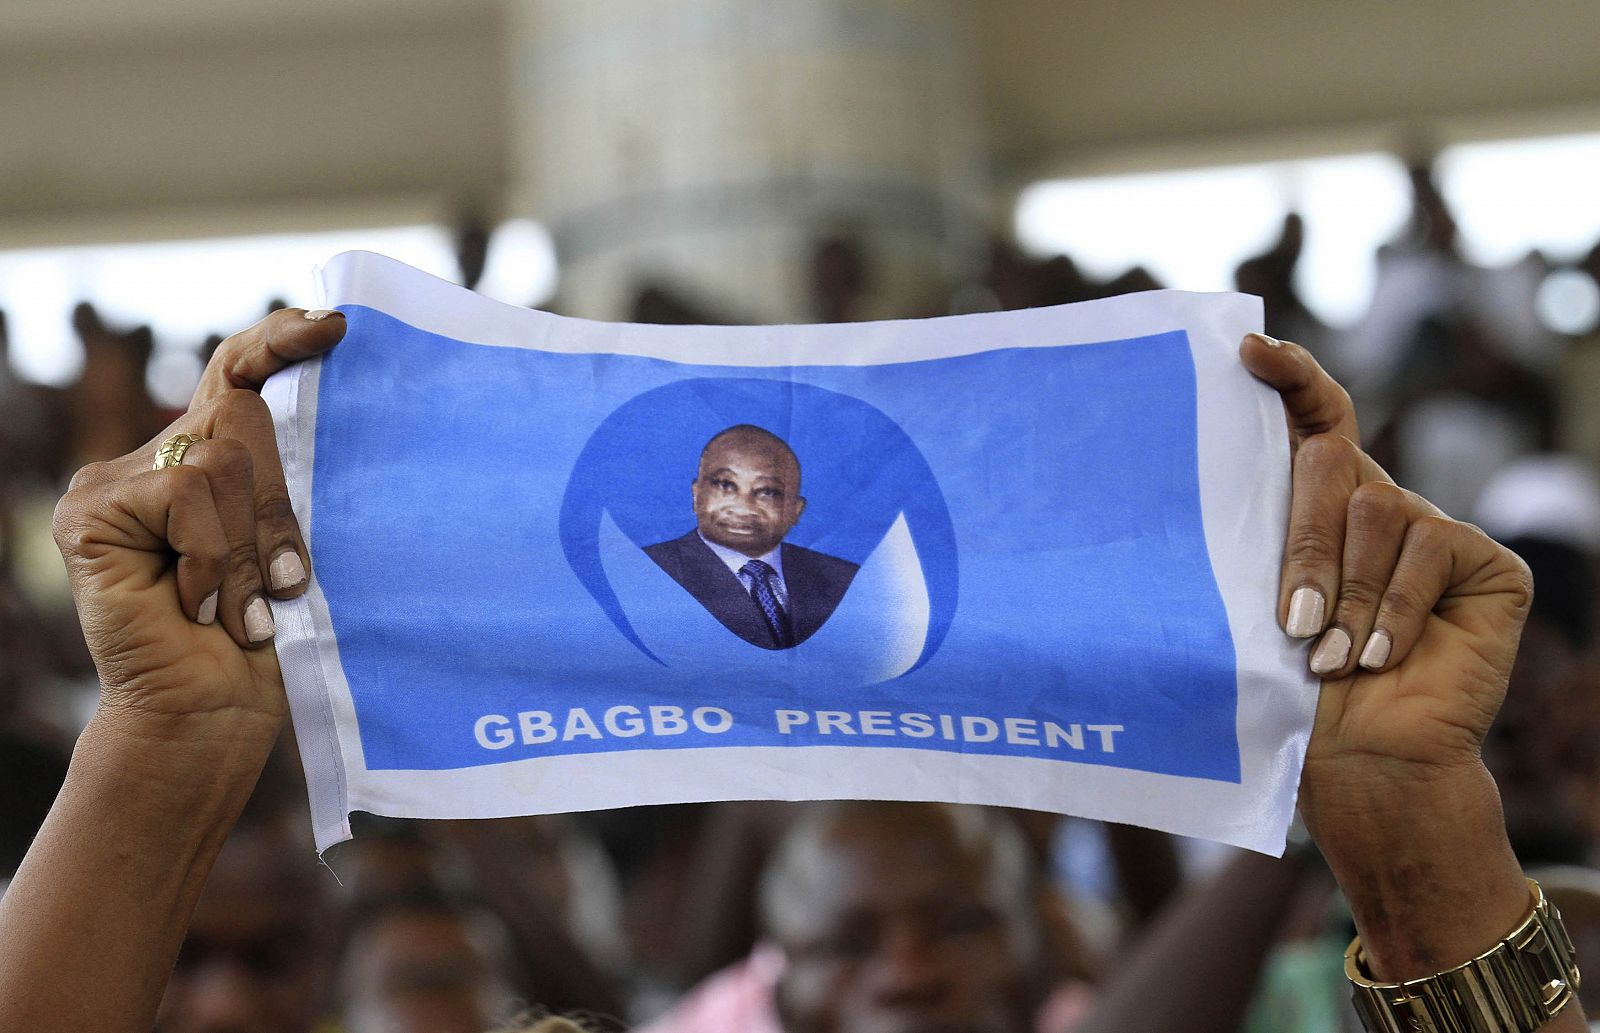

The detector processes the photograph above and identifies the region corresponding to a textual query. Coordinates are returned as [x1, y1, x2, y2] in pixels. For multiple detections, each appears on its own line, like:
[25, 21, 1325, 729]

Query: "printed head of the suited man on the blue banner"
[693, 427, 805, 556]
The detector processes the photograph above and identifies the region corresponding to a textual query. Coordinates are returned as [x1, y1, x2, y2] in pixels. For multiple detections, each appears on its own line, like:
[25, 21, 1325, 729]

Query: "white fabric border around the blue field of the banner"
[262, 251, 1317, 854]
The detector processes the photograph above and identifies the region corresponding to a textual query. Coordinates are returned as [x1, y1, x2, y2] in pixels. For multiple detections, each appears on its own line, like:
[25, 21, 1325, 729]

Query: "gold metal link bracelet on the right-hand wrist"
[1344, 879, 1579, 1033]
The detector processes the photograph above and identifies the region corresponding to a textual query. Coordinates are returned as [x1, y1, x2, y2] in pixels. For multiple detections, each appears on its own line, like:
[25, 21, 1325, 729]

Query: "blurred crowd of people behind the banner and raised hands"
[0, 153, 1600, 1033]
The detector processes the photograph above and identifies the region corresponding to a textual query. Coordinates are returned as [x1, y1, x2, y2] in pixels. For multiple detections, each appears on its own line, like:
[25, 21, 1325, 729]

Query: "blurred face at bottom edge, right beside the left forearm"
[157, 825, 334, 1033]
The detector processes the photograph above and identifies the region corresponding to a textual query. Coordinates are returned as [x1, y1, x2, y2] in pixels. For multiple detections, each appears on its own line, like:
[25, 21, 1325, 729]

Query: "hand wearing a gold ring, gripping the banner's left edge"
[54, 309, 344, 736]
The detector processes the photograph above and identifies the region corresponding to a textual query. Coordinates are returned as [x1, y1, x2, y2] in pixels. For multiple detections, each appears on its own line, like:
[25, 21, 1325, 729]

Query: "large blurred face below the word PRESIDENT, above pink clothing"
[768, 804, 1032, 1033]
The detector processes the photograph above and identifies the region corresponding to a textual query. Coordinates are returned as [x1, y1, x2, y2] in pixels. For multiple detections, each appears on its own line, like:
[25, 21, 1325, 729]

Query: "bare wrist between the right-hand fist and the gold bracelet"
[1302, 761, 1528, 980]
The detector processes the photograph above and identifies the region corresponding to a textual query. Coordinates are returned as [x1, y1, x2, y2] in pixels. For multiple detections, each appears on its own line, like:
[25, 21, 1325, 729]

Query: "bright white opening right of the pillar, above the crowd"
[1016, 133, 1600, 329]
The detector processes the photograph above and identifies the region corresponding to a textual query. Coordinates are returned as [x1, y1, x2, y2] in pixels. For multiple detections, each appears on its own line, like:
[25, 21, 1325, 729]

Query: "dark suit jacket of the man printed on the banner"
[645, 531, 859, 649]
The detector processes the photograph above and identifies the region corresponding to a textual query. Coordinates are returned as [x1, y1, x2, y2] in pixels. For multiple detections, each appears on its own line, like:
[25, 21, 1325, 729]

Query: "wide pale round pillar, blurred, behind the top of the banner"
[510, 0, 986, 321]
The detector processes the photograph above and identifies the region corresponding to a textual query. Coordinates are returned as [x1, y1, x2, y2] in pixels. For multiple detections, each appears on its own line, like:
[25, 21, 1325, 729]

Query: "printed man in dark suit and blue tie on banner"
[645, 424, 858, 649]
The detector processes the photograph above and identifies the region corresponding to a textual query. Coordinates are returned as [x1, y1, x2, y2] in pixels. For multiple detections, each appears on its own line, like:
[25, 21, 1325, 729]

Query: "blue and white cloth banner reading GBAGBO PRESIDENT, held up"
[266, 253, 1315, 852]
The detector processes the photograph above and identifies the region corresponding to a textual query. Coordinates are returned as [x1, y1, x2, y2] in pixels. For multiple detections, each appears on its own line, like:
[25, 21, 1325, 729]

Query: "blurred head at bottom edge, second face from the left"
[341, 908, 514, 1033]
